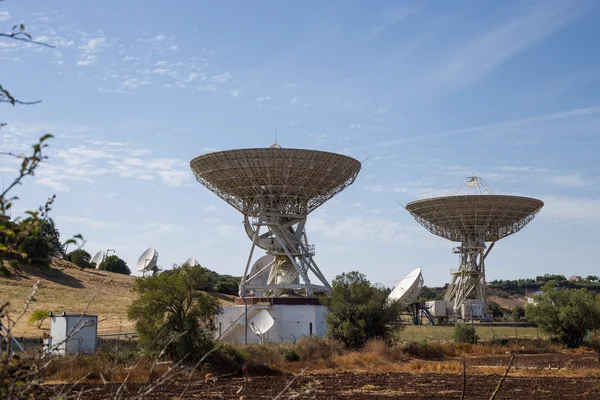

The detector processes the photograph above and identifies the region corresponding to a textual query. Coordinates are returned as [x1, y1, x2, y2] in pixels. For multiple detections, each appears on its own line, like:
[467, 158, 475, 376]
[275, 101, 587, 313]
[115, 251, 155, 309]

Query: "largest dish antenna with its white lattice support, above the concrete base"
[190, 143, 361, 296]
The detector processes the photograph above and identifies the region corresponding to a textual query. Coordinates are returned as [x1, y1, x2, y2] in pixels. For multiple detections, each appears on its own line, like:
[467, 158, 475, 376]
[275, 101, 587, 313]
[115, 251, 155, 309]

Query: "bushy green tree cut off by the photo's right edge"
[525, 282, 600, 348]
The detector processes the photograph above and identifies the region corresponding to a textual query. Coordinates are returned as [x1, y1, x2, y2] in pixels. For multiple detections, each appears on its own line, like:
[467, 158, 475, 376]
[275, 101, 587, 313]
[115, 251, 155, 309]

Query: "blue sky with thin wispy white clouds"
[0, 0, 600, 286]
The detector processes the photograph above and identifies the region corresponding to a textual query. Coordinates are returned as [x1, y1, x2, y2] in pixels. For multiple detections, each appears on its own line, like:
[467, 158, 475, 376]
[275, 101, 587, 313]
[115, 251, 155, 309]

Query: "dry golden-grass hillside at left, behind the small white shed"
[0, 258, 233, 336]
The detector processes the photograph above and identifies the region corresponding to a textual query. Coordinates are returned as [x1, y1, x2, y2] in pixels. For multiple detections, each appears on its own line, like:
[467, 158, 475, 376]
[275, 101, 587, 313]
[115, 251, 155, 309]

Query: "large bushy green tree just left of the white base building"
[128, 265, 221, 361]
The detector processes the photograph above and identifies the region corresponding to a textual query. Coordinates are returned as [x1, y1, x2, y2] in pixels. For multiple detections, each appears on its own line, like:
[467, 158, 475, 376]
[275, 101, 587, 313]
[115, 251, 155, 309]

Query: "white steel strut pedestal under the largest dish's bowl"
[239, 214, 331, 297]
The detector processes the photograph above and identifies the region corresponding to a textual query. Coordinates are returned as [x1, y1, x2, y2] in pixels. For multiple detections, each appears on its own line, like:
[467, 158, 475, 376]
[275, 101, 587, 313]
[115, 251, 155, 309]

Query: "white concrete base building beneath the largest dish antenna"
[215, 297, 327, 344]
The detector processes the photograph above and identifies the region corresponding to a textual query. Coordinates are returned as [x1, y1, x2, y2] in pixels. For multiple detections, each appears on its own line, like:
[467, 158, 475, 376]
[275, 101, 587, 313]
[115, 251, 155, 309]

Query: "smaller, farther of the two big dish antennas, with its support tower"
[405, 176, 544, 315]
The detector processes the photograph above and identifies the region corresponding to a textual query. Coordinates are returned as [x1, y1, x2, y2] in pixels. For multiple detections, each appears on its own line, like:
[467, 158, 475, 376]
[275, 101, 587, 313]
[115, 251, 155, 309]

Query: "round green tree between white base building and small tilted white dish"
[322, 271, 401, 349]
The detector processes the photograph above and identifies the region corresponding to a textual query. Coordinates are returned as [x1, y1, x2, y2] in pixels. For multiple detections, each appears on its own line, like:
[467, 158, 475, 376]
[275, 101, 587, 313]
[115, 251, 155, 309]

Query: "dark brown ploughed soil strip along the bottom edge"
[39, 373, 600, 400]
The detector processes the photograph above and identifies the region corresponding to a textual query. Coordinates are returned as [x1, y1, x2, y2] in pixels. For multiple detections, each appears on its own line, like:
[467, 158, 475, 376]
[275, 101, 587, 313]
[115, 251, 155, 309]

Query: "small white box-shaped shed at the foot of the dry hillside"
[44, 313, 98, 354]
